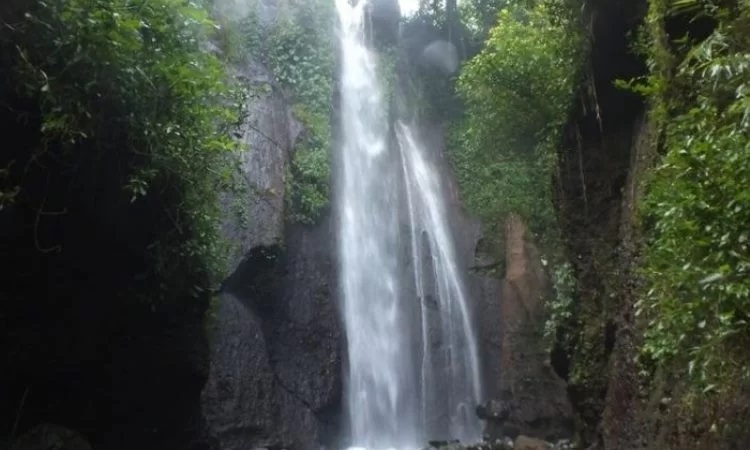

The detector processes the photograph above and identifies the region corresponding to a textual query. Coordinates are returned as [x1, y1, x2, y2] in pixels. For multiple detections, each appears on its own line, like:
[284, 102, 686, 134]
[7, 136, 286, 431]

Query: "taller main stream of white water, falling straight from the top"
[336, 0, 417, 448]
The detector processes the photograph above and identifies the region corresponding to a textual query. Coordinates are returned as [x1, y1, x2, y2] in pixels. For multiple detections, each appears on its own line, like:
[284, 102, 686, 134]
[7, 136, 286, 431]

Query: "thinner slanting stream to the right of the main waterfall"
[396, 122, 481, 442]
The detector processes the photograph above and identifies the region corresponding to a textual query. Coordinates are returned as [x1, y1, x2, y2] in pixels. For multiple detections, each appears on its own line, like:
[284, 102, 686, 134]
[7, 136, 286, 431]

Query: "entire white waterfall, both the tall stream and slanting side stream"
[336, 0, 481, 448]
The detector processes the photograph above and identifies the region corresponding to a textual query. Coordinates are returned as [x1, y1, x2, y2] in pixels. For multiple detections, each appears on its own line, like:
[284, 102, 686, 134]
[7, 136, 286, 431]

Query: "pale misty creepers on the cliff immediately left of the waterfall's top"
[220, 0, 335, 224]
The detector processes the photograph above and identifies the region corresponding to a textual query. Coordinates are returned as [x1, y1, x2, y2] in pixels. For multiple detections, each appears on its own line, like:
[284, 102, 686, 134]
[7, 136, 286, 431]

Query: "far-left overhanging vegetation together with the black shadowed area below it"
[0, 0, 245, 449]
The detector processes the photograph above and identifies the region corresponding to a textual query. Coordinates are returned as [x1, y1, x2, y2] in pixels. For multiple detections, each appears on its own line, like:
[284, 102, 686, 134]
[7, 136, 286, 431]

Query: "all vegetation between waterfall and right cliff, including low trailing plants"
[404, 0, 586, 342]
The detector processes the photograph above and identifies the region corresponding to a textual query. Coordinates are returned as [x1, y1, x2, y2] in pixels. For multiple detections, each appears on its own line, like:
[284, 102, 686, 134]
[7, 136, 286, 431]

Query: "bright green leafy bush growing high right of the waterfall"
[451, 2, 582, 241]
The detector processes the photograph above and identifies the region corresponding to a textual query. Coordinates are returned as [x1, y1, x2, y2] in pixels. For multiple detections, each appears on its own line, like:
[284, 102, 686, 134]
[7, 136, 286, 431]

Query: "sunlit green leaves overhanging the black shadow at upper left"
[0, 0, 242, 298]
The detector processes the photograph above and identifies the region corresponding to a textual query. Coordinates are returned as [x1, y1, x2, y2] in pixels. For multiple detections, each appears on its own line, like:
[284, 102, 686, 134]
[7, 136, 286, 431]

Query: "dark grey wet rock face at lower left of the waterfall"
[202, 216, 342, 450]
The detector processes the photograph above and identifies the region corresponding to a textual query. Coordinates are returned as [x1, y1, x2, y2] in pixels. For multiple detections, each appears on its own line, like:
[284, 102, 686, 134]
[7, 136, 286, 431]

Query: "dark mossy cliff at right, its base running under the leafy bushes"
[558, 0, 750, 450]
